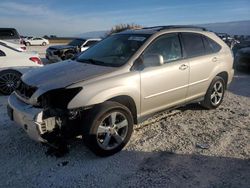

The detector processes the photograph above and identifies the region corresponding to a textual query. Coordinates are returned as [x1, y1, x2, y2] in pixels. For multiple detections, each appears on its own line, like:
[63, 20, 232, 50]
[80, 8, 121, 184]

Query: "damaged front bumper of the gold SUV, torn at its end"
[7, 93, 47, 143]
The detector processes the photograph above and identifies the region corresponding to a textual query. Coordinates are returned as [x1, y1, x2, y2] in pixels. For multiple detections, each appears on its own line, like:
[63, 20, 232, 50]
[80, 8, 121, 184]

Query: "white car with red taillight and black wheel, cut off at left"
[0, 43, 43, 95]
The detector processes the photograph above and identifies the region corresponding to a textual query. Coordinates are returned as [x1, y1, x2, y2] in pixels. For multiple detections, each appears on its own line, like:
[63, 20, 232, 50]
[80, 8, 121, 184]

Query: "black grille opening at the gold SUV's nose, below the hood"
[15, 80, 37, 99]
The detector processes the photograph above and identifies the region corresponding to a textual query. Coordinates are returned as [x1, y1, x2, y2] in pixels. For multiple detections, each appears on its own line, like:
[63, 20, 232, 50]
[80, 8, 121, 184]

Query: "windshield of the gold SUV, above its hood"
[76, 34, 150, 67]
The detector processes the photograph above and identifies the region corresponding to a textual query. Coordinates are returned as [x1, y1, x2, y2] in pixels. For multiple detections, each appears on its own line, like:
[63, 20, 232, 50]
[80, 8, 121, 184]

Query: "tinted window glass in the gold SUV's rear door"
[181, 33, 205, 57]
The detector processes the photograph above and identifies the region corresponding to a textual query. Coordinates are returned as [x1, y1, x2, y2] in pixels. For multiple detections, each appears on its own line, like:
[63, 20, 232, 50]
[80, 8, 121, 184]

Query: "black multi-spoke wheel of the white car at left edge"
[0, 70, 22, 95]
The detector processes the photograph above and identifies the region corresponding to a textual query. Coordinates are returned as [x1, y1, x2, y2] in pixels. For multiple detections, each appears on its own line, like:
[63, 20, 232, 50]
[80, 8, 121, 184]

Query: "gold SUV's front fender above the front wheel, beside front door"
[68, 74, 140, 110]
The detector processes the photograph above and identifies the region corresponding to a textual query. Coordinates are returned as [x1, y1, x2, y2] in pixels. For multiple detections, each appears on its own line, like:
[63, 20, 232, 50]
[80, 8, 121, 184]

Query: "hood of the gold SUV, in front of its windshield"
[22, 60, 116, 90]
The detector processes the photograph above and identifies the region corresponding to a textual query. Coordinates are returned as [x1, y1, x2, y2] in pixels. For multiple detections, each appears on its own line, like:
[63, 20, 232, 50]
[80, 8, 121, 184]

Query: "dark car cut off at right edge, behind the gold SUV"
[235, 46, 250, 70]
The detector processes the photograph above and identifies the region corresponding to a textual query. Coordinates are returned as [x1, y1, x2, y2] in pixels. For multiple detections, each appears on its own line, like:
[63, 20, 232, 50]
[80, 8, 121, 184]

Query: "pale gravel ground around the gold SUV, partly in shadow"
[0, 45, 250, 188]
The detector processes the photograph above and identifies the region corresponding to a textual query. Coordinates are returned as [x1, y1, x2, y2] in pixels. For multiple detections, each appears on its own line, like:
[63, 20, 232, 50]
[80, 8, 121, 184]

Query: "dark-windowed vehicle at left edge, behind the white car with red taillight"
[0, 28, 23, 44]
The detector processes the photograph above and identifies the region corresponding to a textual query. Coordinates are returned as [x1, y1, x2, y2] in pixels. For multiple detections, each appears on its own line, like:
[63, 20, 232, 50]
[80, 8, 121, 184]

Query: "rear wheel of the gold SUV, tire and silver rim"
[201, 76, 226, 109]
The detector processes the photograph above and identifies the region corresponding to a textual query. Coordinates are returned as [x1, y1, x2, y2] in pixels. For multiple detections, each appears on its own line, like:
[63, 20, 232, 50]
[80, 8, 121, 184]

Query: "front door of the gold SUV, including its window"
[140, 33, 189, 116]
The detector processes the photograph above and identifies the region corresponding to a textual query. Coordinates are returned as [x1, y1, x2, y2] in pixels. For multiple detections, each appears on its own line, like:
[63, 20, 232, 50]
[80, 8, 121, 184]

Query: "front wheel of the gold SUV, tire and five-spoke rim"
[83, 101, 133, 157]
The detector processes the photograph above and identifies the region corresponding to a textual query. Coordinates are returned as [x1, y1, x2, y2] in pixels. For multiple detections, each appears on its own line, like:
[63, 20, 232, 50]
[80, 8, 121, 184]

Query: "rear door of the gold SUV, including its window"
[181, 32, 220, 100]
